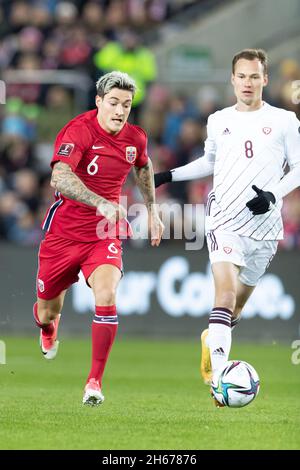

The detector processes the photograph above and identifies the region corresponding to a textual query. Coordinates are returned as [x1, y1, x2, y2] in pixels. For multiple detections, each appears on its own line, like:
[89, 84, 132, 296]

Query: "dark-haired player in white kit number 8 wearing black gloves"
[155, 49, 300, 406]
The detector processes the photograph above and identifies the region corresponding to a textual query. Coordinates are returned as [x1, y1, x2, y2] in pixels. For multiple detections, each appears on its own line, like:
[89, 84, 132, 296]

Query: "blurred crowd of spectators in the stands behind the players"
[0, 0, 300, 249]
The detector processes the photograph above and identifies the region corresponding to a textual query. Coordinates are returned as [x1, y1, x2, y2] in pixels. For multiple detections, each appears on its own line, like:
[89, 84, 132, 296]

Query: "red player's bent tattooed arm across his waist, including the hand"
[50, 162, 126, 222]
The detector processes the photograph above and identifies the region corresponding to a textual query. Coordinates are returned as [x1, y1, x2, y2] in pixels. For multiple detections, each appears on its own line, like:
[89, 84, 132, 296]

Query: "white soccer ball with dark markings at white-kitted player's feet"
[211, 361, 259, 408]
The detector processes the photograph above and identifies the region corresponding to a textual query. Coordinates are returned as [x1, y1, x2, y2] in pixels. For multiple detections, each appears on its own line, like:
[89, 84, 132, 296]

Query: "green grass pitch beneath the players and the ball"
[0, 337, 300, 450]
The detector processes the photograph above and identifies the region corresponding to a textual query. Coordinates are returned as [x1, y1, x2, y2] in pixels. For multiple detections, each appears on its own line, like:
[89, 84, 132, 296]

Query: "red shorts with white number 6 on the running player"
[37, 233, 123, 300]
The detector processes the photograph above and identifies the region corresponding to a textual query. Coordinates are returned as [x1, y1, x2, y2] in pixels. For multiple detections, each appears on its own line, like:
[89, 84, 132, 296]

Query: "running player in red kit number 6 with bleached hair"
[33, 72, 163, 405]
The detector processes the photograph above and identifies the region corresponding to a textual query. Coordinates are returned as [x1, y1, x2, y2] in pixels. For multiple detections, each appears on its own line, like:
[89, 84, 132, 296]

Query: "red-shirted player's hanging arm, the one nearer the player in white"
[134, 158, 164, 246]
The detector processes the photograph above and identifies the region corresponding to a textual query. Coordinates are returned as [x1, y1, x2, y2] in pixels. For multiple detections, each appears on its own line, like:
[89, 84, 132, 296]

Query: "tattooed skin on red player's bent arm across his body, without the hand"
[51, 162, 108, 207]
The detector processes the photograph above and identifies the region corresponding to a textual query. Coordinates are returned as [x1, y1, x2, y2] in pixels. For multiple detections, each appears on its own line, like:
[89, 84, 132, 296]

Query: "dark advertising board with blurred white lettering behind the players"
[0, 245, 300, 341]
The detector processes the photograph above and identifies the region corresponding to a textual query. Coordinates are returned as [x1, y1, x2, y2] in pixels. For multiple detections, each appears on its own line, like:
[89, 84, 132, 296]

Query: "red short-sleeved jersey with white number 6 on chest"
[42, 109, 148, 242]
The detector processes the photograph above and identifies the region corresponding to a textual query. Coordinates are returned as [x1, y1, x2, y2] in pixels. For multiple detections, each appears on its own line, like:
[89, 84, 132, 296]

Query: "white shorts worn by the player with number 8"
[206, 230, 278, 286]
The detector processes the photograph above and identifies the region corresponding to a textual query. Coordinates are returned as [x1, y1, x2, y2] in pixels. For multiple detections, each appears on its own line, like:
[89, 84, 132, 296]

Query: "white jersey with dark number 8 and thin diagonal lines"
[205, 103, 300, 240]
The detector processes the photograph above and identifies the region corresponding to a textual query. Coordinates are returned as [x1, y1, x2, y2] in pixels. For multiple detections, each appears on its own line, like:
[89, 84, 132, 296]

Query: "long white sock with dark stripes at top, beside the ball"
[208, 307, 232, 374]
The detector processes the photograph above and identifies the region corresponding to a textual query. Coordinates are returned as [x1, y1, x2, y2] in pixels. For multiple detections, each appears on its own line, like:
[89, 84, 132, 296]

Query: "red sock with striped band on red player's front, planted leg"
[87, 305, 118, 386]
